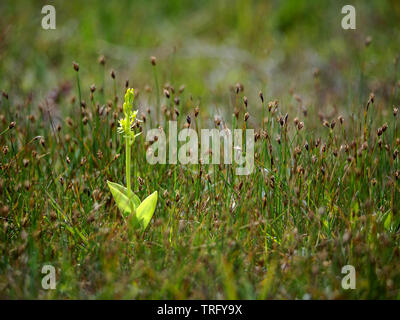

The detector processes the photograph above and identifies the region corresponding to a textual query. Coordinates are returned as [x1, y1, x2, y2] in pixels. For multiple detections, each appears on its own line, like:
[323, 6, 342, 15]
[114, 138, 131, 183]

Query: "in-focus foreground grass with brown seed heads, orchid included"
[0, 55, 400, 299]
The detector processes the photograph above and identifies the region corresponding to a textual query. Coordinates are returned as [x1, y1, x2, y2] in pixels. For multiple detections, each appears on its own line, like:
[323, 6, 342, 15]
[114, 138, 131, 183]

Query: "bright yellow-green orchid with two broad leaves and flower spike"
[107, 89, 157, 231]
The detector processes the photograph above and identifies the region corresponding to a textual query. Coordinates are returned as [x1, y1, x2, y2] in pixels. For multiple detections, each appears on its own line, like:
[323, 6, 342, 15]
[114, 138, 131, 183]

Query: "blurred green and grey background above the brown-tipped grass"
[0, 0, 400, 119]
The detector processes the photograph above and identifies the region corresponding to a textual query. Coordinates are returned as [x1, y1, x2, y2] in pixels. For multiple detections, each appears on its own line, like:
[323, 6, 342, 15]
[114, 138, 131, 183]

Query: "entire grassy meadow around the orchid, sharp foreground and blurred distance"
[0, 0, 400, 299]
